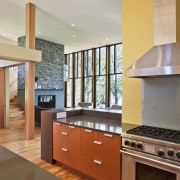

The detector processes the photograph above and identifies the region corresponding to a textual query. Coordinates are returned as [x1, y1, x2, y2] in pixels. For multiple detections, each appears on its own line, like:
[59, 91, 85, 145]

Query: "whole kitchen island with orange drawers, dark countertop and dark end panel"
[41, 108, 122, 180]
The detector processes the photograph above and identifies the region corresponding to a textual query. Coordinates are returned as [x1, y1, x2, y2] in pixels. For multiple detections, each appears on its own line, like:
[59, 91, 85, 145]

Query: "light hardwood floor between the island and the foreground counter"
[0, 120, 89, 180]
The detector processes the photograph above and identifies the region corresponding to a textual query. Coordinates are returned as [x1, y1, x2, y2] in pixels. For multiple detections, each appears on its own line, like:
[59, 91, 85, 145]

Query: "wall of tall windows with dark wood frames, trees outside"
[65, 43, 122, 108]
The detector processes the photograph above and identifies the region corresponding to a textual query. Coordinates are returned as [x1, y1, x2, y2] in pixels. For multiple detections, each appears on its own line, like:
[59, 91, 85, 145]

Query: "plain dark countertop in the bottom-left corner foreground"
[0, 146, 60, 180]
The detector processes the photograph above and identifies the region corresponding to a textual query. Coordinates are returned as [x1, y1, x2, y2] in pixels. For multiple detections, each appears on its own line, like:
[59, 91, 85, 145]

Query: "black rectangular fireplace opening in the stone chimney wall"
[38, 95, 56, 108]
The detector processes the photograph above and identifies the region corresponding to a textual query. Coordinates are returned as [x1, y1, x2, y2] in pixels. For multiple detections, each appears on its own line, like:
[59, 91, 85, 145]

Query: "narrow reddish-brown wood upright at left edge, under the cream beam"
[0, 68, 5, 128]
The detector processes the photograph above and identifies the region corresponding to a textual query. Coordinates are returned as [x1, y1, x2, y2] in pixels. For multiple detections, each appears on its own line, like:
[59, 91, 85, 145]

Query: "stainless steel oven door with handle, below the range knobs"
[121, 150, 180, 180]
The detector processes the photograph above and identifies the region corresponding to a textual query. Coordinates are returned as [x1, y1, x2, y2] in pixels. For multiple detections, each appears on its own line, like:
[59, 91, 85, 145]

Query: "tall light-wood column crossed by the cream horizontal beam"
[25, 3, 36, 139]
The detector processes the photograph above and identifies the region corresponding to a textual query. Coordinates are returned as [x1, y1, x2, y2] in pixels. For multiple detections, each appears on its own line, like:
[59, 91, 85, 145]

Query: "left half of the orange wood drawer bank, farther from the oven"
[53, 122, 80, 169]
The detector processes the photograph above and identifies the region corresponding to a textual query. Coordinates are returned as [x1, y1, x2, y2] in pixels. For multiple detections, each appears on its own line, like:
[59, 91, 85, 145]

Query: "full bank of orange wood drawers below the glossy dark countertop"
[53, 122, 120, 180]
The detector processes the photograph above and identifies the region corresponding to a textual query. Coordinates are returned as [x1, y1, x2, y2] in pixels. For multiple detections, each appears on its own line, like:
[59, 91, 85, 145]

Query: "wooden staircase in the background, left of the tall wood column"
[9, 96, 24, 120]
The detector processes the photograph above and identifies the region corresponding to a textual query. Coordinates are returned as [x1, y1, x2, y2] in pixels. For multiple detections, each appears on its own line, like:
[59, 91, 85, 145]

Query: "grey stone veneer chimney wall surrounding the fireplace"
[18, 36, 64, 108]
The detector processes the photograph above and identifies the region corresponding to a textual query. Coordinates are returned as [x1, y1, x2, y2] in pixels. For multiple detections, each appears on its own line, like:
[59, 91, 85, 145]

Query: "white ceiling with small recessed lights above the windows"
[0, 0, 122, 53]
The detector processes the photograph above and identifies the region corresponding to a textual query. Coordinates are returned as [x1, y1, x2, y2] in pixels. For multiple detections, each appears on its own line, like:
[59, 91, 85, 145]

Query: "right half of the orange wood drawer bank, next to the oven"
[80, 128, 120, 180]
